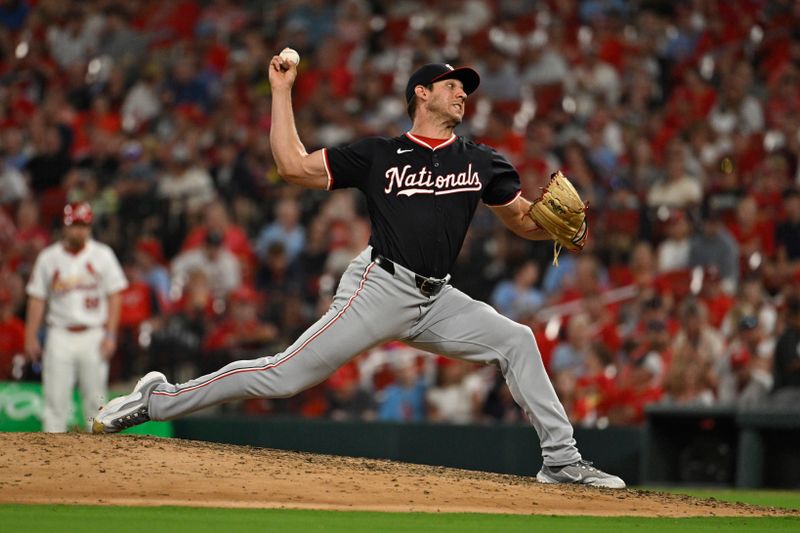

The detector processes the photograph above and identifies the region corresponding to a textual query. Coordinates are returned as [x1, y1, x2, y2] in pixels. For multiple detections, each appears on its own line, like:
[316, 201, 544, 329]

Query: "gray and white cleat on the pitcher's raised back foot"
[92, 372, 168, 433]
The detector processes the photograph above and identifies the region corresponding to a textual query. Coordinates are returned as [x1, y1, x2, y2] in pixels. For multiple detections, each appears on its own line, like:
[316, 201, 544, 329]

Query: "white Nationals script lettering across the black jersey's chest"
[383, 163, 481, 196]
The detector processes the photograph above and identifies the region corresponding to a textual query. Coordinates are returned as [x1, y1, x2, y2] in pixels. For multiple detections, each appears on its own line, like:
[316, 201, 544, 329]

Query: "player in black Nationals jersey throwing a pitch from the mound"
[94, 56, 625, 488]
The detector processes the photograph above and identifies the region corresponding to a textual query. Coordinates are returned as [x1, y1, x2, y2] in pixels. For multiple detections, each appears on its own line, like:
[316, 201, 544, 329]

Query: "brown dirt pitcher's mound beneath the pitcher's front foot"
[0, 433, 789, 517]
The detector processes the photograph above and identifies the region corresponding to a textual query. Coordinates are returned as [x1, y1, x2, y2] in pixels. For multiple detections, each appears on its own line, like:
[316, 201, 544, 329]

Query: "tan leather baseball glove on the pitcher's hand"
[528, 170, 589, 266]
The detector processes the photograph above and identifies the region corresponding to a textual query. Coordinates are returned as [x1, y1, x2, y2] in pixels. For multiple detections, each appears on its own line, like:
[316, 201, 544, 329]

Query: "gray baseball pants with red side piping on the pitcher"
[148, 247, 581, 466]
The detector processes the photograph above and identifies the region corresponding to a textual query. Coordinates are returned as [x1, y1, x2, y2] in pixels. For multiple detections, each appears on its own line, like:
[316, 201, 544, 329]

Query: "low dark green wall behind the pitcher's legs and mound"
[173, 416, 642, 484]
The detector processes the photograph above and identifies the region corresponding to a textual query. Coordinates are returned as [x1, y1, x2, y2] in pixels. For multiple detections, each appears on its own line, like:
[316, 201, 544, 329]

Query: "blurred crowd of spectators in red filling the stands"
[0, 0, 800, 426]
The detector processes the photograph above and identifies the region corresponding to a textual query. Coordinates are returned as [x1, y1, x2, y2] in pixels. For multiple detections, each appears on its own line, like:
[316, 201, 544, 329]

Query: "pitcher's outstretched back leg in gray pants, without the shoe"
[148, 254, 408, 420]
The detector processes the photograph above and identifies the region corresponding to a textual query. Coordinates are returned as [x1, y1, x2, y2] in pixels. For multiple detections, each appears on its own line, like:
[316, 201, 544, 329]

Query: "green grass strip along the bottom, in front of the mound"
[0, 505, 800, 533]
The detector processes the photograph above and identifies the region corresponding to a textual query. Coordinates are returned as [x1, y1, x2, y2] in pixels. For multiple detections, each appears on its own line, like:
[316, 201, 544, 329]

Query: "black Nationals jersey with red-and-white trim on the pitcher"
[324, 133, 520, 278]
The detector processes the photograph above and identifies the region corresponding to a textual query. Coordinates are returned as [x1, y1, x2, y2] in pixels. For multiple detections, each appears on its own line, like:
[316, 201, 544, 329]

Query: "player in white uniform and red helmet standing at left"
[25, 202, 128, 433]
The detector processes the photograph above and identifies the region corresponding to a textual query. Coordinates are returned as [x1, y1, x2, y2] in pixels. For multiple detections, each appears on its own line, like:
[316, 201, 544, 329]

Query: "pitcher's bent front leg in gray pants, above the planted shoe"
[404, 287, 581, 466]
